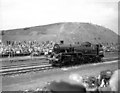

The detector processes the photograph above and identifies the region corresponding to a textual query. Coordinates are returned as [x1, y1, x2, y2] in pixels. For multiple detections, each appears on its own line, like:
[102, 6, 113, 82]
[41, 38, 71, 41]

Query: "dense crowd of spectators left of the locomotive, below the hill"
[0, 41, 55, 57]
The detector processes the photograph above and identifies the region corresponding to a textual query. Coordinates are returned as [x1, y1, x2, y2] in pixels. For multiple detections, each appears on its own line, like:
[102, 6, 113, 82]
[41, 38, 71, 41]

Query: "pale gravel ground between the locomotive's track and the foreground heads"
[2, 59, 118, 91]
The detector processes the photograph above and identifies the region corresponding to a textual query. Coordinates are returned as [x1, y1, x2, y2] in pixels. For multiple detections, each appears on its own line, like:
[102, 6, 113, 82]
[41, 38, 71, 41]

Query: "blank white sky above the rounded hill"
[0, 0, 119, 33]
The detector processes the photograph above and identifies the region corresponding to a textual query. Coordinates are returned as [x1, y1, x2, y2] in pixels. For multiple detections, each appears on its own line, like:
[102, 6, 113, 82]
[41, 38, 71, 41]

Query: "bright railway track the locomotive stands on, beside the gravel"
[0, 57, 118, 76]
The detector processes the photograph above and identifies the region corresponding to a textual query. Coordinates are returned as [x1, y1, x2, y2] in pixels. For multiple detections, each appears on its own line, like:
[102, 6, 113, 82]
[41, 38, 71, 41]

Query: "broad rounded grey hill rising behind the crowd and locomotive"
[1, 22, 118, 44]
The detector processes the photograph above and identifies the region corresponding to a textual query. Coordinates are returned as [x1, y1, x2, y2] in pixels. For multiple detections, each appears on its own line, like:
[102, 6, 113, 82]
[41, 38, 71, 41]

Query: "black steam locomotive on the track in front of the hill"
[49, 42, 104, 67]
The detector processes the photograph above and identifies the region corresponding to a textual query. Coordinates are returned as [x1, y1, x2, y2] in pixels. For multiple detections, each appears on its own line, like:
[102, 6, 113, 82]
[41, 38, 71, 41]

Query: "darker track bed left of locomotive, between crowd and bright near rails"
[1, 57, 48, 69]
